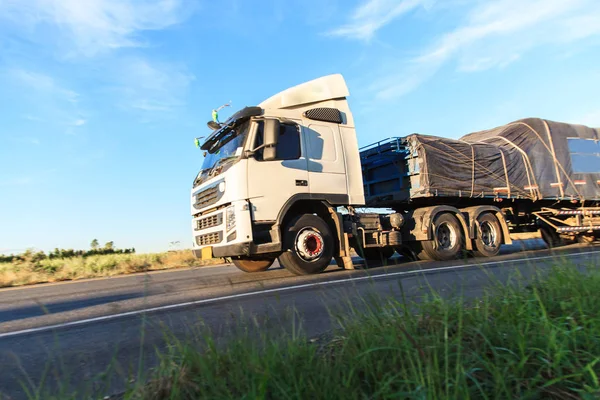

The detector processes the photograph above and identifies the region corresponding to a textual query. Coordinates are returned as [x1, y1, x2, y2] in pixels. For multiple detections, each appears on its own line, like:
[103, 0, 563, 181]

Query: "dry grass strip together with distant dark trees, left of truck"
[0, 240, 224, 287]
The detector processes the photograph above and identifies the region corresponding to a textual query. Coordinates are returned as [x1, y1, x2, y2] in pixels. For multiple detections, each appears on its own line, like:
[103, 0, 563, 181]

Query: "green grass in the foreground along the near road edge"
[32, 267, 600, 400]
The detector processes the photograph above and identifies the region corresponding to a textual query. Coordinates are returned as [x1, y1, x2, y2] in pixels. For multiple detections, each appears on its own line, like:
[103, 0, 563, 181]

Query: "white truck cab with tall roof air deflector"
[191, 75, 365, 273]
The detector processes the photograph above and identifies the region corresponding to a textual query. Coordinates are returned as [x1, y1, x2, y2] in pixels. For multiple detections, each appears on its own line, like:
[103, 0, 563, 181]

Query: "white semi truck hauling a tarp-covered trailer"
[191, 75, 600, 274]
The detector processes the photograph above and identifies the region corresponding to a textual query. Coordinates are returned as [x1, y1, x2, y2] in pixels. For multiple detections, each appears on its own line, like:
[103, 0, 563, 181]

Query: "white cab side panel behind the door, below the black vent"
[304, 122, 348, 195]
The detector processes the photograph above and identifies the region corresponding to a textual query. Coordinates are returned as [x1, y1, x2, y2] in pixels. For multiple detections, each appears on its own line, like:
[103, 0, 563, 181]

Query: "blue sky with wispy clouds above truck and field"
[0, 0, 600, 252]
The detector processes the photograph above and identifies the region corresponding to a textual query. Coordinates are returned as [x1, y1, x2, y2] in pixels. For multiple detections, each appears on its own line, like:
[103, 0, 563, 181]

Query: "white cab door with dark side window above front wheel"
[247, 121, 309, 221]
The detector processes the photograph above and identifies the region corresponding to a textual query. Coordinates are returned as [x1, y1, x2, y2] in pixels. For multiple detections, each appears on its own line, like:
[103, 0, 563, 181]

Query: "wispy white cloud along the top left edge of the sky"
[0, 0, 194, 56]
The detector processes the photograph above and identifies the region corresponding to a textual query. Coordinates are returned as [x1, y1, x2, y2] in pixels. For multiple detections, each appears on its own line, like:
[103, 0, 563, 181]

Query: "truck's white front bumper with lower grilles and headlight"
[192, 200, 252, 260]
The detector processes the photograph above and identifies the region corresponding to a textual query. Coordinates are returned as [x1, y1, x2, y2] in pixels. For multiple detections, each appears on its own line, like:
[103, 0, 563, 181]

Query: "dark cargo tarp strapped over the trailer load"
[407, 118, 600, 200]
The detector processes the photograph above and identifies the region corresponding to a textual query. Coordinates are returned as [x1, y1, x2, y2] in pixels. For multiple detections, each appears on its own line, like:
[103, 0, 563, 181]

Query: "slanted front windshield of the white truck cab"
[194, 121, 249, 187]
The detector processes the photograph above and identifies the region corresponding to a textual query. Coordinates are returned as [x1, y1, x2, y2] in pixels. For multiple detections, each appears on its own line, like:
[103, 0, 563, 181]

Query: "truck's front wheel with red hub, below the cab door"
[279, 214, 335, 275]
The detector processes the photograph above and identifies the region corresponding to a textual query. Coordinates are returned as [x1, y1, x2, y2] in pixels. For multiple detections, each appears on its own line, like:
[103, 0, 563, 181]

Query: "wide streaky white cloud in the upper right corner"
[370, 0, 600, 100]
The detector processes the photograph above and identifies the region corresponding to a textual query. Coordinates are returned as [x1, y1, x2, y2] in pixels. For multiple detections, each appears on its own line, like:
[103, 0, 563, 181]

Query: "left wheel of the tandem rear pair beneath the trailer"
[416, 213, 465, 261]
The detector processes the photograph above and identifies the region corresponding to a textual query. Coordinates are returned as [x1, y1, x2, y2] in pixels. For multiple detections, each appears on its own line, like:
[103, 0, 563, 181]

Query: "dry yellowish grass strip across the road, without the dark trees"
[0, 251, 223, 287]
